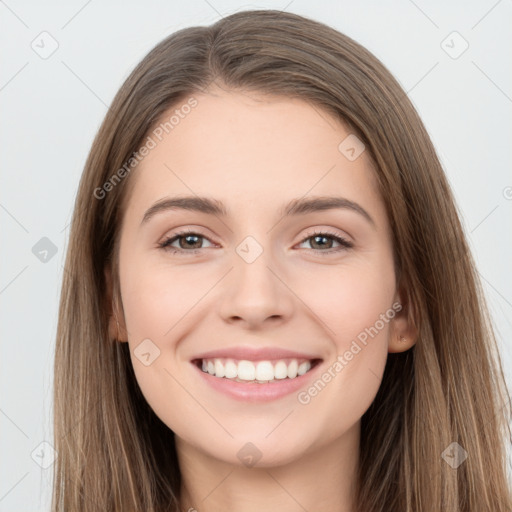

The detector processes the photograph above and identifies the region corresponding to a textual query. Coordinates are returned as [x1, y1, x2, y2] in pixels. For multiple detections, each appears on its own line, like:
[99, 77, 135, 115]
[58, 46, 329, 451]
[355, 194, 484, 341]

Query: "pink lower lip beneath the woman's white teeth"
[192, 361, 321, 402]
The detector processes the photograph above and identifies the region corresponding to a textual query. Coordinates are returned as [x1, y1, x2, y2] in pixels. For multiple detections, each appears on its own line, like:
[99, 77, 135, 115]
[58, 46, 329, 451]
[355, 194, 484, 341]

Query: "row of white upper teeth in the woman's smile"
[202, 358, 311, 382]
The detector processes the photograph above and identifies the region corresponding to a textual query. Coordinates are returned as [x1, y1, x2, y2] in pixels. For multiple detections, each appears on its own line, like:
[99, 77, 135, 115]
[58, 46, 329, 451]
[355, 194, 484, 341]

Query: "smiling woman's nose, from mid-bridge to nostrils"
[220, 251, 293, 329]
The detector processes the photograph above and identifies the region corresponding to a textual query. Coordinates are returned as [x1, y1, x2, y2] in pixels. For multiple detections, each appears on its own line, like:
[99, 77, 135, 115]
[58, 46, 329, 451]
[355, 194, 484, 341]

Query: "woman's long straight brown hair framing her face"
[52, 10, 512, 512]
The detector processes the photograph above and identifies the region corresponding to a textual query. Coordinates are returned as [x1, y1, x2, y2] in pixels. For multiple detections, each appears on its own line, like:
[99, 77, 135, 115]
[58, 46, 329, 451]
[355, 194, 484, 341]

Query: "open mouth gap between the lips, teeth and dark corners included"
[191, 357, 322, 384]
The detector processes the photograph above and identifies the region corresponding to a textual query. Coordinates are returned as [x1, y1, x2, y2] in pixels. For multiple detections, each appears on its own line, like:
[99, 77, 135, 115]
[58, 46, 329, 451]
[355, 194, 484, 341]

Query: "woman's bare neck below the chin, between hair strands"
[176, 422, 360, 512]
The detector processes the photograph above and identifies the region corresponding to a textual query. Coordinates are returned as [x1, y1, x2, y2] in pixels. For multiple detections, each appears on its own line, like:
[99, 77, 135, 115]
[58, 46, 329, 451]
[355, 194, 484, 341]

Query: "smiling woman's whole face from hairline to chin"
[108, 90, 416, 466]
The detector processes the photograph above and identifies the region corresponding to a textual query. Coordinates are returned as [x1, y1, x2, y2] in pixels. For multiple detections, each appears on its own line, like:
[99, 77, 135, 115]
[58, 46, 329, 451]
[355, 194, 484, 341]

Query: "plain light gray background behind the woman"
[0, 0, 512, 511]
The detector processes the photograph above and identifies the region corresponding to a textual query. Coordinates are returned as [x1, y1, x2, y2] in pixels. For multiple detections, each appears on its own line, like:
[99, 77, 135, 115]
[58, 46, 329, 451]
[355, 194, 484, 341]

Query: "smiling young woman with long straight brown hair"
[53, 11, 512, 512]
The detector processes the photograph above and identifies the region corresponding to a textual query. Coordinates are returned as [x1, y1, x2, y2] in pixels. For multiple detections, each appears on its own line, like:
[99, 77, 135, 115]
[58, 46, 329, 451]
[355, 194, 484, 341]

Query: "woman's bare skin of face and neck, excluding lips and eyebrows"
[107, 88, 416, 512]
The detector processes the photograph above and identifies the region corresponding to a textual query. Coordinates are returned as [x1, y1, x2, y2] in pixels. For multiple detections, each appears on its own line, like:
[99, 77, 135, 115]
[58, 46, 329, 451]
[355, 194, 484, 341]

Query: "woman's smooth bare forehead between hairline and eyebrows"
[122, 89, 379, 222]
